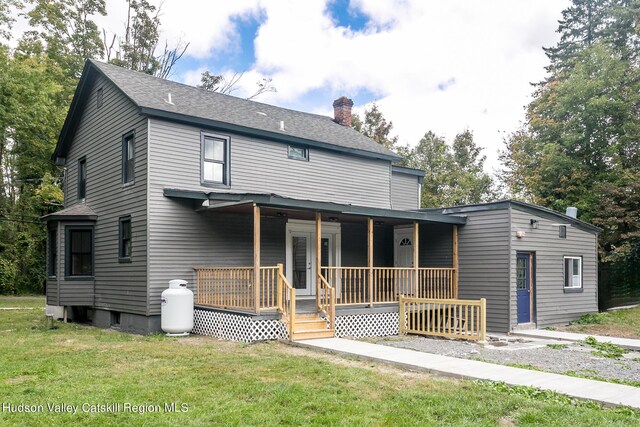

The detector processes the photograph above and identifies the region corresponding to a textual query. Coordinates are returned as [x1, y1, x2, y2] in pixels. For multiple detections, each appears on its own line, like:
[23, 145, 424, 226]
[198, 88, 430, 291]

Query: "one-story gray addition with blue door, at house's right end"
[439, 201, 600, 332]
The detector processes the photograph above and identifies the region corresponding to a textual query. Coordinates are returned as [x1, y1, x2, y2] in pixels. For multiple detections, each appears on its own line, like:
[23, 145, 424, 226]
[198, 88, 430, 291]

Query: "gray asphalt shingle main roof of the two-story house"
[90, 60, 398, 159]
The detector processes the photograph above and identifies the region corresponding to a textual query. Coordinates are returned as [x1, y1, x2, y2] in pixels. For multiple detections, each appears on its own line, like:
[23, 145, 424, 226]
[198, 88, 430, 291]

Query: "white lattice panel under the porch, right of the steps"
[336, 312, 400, 338]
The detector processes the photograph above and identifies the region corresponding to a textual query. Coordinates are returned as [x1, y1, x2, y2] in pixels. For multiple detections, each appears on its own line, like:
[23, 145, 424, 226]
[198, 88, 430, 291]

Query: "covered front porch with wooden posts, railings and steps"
[165, 193, 464, 337]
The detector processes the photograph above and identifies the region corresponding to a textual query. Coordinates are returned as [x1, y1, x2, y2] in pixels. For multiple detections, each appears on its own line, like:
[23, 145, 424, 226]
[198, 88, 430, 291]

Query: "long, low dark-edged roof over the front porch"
[164, 188, 467, 225]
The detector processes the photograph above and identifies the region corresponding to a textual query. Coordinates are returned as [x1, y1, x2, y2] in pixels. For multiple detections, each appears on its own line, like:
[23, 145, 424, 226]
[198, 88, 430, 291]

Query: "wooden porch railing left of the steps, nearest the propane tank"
[195, 267, 278, 311]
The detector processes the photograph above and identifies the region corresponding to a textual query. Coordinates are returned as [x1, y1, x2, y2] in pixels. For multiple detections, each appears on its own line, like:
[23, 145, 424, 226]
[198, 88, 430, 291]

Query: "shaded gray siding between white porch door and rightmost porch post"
[418, 224, 453, 268]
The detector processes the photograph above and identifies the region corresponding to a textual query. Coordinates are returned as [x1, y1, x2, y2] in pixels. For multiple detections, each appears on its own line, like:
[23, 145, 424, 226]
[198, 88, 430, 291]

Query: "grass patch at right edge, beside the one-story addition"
[558, 306, 640, 339]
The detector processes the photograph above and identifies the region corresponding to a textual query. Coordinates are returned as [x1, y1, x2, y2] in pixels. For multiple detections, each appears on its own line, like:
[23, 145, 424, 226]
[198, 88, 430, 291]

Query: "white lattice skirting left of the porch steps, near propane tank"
[193, 308, 289, 343]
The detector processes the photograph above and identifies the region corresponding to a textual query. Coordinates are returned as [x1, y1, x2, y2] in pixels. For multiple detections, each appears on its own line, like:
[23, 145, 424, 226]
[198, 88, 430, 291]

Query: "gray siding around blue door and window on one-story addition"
[510, 207, 598, 327]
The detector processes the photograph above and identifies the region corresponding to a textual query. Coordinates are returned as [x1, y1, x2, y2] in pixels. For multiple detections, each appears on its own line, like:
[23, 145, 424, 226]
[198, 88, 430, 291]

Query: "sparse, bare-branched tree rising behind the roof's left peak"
[103, 0, 189, 79]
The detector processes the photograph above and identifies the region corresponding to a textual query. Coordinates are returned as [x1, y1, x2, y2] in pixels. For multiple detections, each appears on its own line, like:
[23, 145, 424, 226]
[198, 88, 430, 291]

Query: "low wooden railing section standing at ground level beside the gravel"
[400, 296, 487, 341]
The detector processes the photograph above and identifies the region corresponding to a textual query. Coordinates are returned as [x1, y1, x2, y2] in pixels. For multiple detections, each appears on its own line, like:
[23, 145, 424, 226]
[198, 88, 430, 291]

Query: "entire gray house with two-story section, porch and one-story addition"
[46, 61, 596, 341]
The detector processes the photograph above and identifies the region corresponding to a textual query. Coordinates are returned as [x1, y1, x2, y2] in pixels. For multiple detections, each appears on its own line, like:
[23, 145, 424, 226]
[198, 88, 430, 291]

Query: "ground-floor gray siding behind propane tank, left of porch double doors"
[148, 200, 286, 315]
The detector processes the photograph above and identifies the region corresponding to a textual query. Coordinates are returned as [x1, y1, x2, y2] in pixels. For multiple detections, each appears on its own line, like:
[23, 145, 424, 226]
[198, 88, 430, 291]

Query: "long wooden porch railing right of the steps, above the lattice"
[321, 267, 458, 305]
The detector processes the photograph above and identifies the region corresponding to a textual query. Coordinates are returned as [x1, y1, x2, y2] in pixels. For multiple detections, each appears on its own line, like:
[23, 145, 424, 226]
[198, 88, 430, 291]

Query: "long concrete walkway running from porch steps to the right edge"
[296, 338, 640, 408]
